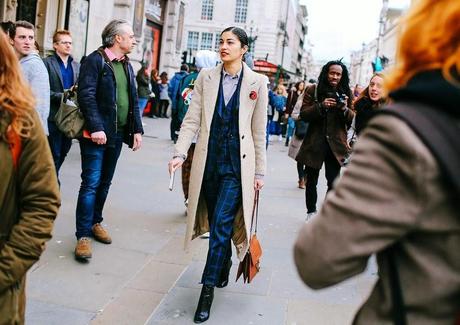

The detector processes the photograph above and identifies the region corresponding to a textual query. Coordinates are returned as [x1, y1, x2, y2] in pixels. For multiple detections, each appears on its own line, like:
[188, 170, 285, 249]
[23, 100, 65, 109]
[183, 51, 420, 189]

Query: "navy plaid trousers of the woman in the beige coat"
[201, 163, 242, 286]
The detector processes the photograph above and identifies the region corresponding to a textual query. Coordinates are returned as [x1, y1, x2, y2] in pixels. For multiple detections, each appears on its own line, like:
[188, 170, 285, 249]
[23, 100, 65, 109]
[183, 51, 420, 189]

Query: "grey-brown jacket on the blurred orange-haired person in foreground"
[295, 116, 460, 325]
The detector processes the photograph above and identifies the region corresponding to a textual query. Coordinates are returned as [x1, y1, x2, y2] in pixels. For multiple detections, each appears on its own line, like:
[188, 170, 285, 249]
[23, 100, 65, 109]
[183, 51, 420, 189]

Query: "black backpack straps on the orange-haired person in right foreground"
[377, 102, 460, 325]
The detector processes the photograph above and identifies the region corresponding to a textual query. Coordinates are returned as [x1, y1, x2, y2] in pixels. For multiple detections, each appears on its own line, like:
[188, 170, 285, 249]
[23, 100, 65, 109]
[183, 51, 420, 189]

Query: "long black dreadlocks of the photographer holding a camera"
[318, 60, 352, 107]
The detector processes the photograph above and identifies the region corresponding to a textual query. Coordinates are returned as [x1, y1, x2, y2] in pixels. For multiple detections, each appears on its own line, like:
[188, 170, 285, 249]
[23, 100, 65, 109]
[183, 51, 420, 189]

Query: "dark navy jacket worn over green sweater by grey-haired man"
[78, 48, 143, 146]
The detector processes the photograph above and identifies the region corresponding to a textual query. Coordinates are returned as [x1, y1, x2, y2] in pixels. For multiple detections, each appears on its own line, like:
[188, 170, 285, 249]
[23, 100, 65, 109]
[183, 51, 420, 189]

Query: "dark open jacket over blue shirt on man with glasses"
[43, 54, 80, 121]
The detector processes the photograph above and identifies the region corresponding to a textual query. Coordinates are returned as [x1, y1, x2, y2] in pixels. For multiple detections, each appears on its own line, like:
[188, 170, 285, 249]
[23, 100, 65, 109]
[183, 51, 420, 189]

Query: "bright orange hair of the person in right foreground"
[385, 0, 460, 92]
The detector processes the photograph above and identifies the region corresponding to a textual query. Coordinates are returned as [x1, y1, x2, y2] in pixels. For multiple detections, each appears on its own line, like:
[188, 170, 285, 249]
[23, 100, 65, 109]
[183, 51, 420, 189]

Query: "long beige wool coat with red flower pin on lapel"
[175, 63, 268, 260]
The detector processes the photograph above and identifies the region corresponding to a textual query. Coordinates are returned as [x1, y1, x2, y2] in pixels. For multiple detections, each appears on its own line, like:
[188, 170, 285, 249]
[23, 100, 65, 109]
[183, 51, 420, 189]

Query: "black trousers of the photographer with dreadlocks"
[305, 142, 341, 213]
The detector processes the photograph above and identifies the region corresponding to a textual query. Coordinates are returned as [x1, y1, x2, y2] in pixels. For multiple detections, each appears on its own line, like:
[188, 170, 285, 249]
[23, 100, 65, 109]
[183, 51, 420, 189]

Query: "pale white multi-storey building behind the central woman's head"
[182, 0, 308, 77]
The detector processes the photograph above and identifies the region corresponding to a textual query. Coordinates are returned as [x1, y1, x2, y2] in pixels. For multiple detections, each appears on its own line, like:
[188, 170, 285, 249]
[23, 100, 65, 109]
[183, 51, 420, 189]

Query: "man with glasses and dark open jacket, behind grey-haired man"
[43, 30, 80, 177]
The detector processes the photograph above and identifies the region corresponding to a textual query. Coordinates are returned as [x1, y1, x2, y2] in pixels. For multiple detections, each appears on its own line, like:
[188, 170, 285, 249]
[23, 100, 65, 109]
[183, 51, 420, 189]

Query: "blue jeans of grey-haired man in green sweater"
[75, 133, 123, 239]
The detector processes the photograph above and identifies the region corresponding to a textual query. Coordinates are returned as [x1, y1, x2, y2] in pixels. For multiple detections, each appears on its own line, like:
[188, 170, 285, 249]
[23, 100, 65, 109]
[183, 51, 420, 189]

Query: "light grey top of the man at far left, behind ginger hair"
[19, 53, 50, 135]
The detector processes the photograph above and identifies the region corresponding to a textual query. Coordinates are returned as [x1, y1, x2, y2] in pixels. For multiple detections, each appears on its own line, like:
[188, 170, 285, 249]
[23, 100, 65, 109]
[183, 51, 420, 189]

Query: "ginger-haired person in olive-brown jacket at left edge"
[0, 30, 61, 324]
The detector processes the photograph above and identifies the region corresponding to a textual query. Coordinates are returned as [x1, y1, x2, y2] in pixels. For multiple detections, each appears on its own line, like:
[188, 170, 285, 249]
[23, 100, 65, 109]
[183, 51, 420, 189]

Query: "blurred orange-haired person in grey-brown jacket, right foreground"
[294, 0, 460, 325]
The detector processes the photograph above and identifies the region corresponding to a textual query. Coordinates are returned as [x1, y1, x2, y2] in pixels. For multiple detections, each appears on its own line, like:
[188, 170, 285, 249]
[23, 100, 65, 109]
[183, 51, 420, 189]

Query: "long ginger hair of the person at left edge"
[0, 31, 35, 140]
